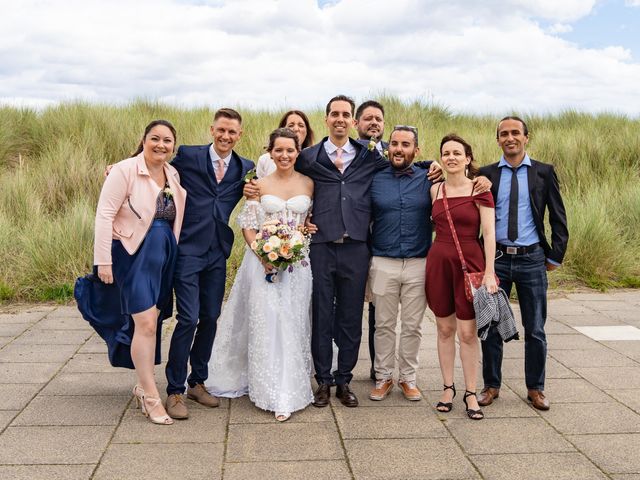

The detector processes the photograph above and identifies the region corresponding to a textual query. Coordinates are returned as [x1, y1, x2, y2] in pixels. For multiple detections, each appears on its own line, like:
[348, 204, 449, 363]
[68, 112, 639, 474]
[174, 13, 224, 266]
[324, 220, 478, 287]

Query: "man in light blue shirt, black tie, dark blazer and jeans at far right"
[478, 117, 569, 410]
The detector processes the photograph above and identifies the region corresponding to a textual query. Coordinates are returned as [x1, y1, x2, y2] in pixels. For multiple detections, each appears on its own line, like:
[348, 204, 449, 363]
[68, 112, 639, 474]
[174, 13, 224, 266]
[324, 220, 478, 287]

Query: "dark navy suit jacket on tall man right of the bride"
[296, 137, 388, 243]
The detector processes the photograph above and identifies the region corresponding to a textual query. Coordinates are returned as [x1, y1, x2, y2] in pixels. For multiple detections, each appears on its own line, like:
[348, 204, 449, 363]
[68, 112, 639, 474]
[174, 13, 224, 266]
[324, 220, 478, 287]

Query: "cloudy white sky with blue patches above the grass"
[0, 0, 640, 117]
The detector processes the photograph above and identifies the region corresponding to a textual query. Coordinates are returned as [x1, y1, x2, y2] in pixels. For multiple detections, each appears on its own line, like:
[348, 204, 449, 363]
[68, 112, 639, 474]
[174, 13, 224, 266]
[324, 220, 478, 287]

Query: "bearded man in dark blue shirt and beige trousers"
[369, 126, 431, 400]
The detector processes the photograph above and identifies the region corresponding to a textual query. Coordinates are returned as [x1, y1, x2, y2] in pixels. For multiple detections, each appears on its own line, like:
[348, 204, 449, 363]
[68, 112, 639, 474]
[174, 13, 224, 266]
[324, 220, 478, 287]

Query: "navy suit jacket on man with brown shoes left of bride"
[171, 145, 255, 258]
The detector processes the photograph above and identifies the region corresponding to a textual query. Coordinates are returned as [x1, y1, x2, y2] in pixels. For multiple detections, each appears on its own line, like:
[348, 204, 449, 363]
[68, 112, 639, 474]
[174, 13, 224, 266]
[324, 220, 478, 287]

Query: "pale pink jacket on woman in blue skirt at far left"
[93, 153, 187, 265]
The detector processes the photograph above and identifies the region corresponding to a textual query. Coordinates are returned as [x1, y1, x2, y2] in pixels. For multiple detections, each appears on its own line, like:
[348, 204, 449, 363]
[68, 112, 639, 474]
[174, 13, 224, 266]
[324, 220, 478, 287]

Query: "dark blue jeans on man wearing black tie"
[482, 247, 547, 390]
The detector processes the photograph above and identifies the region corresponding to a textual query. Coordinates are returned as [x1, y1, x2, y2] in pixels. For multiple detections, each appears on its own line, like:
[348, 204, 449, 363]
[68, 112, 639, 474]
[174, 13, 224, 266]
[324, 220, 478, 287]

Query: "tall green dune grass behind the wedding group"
[0, 96, 640, 301]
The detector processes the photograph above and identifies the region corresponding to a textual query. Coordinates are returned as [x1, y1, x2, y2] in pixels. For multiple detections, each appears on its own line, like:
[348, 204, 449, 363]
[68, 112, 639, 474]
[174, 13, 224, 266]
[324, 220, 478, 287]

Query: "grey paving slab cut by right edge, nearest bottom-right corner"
[567, 433, 640, 474]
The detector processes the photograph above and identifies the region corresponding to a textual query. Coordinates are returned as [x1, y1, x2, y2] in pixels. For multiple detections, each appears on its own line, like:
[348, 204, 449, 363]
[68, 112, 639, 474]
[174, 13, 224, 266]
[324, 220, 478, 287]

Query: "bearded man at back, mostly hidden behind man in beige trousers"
[356, 100, 389, 382]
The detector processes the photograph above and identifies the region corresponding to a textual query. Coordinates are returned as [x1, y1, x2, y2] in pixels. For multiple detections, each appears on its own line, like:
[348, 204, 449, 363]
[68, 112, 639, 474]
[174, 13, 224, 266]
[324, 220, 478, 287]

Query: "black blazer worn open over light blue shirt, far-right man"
[480, 159, 569, 263]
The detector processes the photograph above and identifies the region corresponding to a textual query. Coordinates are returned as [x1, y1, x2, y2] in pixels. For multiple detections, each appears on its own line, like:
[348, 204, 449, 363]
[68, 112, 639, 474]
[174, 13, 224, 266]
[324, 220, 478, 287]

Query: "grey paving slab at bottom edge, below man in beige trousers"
[344, 438, 480, 480]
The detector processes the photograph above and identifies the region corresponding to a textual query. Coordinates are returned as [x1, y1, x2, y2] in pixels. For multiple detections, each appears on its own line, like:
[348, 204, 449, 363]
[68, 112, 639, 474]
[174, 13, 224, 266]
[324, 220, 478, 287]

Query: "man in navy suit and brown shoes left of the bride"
[166, 108, 254, 419]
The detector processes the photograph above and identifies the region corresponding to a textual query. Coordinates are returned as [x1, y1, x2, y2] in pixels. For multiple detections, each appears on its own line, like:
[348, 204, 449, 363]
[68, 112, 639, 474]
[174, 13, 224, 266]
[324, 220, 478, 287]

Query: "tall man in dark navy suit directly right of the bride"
[296, 95, 387, 407]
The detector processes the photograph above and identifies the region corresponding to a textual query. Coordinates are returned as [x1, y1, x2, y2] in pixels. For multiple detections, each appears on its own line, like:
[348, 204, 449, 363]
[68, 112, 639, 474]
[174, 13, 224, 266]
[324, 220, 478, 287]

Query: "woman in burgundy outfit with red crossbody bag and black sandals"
[425, 134, 498, 420]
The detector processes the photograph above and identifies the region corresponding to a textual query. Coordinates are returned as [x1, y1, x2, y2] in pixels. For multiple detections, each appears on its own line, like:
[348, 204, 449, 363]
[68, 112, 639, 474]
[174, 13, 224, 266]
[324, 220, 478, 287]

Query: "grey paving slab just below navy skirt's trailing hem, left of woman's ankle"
[41, 369, 136, 396]
